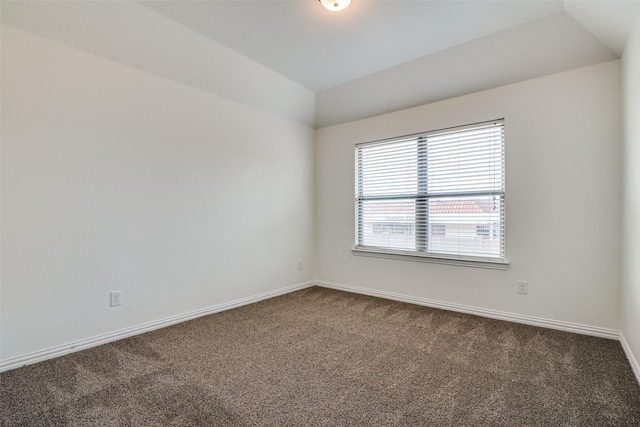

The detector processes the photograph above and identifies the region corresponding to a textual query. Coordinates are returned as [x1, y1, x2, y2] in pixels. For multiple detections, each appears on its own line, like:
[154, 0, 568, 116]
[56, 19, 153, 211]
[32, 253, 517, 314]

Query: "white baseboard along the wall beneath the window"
[316, 280, 620, 340]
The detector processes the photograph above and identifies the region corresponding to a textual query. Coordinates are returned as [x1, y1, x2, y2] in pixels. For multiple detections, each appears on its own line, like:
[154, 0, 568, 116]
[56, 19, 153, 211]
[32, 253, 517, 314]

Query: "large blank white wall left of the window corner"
[0, 26, 314, 360]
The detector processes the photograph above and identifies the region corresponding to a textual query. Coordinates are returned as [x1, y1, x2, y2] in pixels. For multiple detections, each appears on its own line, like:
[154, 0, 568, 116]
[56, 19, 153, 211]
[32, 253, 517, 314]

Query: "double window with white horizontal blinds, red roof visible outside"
[355, 120, 505, 263]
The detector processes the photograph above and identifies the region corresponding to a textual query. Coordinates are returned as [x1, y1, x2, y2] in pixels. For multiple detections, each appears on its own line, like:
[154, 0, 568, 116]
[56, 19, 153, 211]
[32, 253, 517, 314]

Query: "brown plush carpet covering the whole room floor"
[0, 287, 640, 427]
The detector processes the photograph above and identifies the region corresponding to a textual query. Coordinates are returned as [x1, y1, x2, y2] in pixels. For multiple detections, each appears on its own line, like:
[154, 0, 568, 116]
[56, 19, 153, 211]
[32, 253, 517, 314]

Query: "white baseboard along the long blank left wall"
[0, 282, 315, 372]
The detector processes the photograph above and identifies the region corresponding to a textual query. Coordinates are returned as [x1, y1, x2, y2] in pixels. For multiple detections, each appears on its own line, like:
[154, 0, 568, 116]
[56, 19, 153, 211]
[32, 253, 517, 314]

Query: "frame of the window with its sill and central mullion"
[352, 118, 509, 270]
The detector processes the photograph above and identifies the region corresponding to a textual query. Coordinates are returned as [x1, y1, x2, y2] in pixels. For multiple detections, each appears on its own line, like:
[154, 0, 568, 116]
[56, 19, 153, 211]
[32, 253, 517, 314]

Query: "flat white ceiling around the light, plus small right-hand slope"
[142, 0, 640, 91]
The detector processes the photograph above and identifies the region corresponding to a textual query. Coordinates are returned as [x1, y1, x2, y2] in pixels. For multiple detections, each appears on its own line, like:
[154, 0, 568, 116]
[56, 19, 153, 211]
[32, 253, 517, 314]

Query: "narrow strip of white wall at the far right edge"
[620, 15, 640, 379]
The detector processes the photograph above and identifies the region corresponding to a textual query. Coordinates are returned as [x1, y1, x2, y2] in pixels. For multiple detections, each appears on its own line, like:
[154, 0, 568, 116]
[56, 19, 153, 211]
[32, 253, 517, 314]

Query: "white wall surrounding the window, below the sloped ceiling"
[316, 60, 621, 329]
